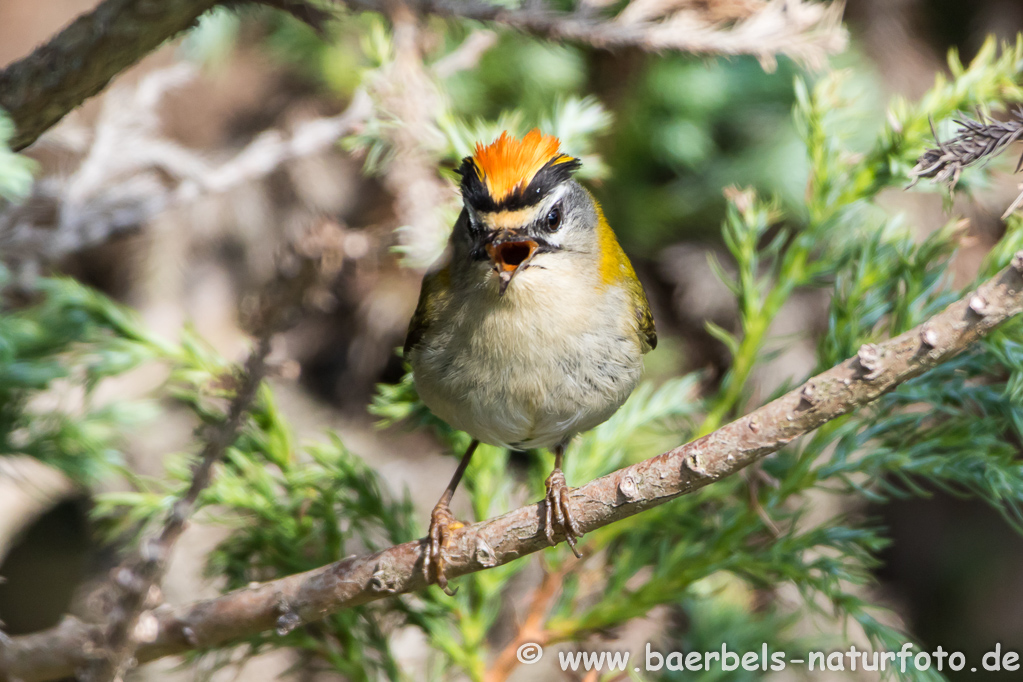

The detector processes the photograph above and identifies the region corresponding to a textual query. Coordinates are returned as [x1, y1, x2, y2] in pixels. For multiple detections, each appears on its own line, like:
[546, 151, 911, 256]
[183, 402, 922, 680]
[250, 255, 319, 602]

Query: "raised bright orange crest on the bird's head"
[473, 128, 574, 202]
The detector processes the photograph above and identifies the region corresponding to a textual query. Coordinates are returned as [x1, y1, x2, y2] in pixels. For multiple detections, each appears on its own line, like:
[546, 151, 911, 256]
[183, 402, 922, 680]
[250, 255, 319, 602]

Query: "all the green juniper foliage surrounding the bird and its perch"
[0, 21, 1023, 680]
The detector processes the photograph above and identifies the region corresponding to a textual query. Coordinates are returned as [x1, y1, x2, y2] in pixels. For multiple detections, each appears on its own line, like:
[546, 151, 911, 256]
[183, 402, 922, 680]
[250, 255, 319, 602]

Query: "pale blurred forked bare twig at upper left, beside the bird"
[0, 64, 372, 277]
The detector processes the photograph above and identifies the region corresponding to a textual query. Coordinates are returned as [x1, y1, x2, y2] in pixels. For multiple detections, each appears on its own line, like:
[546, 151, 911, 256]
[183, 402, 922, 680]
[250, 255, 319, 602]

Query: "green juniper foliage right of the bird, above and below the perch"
[368, 33, 1023, 680]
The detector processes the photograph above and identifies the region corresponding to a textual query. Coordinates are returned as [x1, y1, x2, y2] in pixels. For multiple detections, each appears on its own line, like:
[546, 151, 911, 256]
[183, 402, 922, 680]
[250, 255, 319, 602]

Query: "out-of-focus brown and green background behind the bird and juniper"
[0, 0, 1023, 680]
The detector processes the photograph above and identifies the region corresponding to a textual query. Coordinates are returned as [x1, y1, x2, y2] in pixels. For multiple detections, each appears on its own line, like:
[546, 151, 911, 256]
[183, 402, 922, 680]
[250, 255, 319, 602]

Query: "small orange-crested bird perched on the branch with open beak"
[403, 129, 657, 594]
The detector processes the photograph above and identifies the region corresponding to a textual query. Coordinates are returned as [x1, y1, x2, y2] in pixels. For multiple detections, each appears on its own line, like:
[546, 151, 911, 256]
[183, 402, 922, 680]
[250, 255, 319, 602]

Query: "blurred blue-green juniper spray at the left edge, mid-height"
[0, 268, 160, 483]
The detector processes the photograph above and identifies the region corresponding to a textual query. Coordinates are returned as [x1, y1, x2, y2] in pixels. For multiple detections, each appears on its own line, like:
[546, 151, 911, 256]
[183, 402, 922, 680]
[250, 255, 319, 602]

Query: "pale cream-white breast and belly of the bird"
[410, 259, 642, 448]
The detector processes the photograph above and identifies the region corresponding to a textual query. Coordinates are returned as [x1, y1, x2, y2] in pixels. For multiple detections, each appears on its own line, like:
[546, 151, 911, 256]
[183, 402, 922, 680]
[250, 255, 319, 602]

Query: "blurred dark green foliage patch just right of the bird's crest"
[599, 55, 806, 253]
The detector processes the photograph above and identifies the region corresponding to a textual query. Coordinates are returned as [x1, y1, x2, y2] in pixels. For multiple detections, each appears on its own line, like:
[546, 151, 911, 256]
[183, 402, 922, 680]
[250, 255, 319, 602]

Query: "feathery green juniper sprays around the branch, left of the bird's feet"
[96, 388, 416, 680]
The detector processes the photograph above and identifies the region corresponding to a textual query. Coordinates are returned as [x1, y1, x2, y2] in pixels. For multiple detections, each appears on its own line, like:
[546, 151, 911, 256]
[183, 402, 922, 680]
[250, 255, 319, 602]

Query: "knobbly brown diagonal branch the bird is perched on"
[0, 252, 1023, 682]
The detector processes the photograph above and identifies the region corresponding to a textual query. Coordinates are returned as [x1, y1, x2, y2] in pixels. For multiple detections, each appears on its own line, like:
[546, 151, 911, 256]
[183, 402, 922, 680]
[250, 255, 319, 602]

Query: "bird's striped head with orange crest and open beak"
[452, 129, 599, 294]
